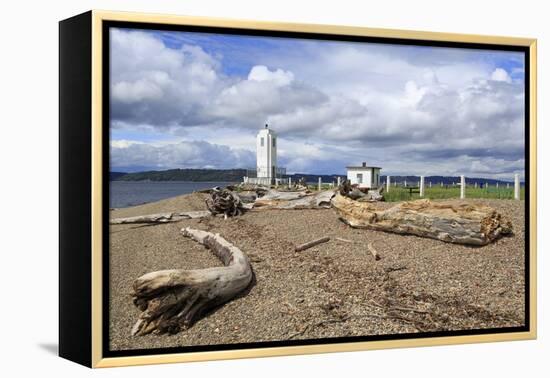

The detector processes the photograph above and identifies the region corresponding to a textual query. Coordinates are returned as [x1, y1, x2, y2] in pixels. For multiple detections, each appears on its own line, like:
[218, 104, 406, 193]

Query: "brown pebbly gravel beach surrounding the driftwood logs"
[110, 193, 525, 350]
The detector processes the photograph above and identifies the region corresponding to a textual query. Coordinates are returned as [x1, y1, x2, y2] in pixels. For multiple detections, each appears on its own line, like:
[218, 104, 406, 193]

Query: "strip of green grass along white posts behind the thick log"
[384, 186, 525, 202]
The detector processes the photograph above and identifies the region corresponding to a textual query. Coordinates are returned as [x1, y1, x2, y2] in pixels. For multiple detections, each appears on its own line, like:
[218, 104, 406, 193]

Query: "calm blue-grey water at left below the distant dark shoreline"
[110, 181, 234, 208]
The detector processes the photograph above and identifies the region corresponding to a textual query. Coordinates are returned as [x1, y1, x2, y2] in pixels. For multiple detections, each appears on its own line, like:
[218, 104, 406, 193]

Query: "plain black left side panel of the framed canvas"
[59, 11, 92, 367]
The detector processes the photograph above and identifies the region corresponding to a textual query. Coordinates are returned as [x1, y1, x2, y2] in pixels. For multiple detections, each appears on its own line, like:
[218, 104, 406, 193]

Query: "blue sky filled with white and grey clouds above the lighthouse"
[110, 29, 525, 179]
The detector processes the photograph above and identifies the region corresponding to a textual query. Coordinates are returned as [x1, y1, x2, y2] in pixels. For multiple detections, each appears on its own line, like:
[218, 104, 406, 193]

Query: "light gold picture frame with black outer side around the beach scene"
[60, 10, 537, 367]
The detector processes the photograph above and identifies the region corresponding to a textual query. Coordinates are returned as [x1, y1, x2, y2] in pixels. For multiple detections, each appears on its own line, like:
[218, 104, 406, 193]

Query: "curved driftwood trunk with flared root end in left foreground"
[132, 227, 252, 335]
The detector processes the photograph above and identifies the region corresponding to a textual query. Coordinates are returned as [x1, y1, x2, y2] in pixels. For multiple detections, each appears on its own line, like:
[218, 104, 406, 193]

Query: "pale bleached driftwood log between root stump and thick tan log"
[254, 190, 334, 210]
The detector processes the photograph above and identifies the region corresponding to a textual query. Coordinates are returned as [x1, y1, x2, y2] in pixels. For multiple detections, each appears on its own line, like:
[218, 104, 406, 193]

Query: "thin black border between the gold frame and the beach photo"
[102, 21, 531, 357]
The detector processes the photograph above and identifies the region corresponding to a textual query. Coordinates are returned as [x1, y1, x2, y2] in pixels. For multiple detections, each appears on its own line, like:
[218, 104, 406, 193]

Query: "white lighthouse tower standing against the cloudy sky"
[256, 124, 277, 185]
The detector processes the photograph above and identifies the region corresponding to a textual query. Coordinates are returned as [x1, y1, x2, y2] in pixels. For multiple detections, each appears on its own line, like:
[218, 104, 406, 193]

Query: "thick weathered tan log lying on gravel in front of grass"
[332, 194, 512, 245]
